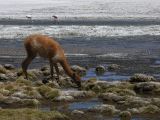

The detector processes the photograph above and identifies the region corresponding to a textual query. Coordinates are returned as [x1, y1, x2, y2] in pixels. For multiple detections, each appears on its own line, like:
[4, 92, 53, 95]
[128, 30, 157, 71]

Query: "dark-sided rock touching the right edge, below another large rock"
[134, 82, 160, 94]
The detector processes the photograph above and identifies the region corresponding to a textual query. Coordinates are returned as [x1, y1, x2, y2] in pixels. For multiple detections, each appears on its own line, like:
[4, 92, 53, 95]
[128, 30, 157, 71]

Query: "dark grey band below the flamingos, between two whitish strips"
[0, 17, 160, 25]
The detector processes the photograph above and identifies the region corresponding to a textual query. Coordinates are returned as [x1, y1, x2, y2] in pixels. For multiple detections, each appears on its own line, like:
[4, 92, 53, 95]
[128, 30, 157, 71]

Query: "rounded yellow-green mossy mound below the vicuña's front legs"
[38, 85, 59, 100]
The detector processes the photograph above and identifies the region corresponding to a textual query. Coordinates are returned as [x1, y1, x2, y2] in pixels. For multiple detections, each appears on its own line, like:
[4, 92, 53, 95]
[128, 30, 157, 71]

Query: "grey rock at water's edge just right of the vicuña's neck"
[71, 65, 87, 75]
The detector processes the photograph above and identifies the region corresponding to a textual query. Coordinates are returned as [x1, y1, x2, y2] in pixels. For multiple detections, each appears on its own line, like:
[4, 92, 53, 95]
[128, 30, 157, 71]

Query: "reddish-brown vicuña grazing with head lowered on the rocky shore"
[22, 34, 81, 87]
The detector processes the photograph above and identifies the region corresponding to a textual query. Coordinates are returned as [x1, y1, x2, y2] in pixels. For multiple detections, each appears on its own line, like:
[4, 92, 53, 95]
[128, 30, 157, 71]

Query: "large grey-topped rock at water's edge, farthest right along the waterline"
[130, 74, 155, 82]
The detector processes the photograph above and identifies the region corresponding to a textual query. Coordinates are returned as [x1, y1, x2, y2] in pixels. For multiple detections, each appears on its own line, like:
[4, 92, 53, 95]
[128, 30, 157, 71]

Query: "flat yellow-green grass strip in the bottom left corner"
[0, 108, 68, 120]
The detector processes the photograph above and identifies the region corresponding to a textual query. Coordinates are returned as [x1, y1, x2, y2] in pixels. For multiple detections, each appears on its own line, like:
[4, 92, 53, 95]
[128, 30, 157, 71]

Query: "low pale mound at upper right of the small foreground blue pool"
[99, 93, 125, 102]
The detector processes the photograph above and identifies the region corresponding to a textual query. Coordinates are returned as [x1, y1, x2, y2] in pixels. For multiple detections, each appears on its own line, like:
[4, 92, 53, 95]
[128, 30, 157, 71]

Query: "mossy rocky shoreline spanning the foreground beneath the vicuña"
[0, 64, 160, 120]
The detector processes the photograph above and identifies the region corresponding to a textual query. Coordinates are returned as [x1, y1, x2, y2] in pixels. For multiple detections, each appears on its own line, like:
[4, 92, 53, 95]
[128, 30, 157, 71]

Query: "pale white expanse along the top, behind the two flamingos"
[0, 0, 160, 19]
